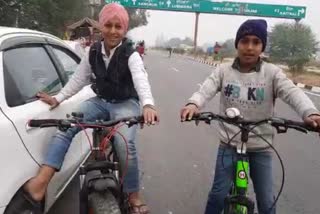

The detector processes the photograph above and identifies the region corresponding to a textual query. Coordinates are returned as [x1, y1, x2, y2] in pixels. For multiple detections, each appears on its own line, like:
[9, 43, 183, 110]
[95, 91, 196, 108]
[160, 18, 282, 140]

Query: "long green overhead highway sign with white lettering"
[105, 0, 306, 19]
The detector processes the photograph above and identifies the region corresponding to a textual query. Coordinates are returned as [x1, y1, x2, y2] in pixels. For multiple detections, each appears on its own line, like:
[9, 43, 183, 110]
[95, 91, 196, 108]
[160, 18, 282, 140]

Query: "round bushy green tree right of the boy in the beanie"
[270, 23, 318, 75]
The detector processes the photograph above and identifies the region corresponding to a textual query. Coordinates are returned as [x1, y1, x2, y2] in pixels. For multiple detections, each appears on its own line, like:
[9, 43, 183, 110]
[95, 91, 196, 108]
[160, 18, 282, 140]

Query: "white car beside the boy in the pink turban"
[0, 27, 94, 214]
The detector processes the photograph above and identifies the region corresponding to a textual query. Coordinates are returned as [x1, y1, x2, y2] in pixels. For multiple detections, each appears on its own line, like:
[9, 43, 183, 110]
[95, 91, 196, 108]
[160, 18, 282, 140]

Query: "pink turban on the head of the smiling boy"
[99, 3, 129, 31]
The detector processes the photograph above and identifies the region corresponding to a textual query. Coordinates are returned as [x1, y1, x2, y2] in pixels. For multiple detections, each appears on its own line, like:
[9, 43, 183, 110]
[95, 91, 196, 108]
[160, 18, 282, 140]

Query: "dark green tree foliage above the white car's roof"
[0, 0, 86, 36]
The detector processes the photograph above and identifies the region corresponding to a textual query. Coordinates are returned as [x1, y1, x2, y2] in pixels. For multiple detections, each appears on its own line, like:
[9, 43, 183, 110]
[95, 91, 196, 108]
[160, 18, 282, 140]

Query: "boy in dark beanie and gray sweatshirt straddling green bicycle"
[181, 19, 320, 214]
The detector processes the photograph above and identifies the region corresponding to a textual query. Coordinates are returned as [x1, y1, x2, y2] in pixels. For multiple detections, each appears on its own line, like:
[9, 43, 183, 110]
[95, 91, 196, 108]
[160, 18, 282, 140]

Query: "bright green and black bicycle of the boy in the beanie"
[186, 108, 319, 214]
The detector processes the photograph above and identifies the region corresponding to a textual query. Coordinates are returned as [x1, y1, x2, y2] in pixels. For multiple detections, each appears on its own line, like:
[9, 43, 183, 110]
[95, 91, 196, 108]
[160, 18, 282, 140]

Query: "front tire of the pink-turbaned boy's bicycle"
[88, 191, 121, 214]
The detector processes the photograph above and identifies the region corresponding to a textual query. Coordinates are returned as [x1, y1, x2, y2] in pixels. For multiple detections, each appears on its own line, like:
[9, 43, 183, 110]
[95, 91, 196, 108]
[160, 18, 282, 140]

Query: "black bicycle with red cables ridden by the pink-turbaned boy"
[28, 112, 144, 214]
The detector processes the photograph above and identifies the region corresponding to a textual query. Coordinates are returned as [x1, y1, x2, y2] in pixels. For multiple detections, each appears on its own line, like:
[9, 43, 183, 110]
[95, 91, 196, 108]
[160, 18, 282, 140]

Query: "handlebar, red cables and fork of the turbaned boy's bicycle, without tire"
[28, 112, 144, 214]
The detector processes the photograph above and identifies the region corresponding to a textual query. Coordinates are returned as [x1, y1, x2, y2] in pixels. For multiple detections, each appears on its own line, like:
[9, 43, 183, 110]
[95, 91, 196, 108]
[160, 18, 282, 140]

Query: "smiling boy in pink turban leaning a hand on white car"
[23, 3, 159, 214]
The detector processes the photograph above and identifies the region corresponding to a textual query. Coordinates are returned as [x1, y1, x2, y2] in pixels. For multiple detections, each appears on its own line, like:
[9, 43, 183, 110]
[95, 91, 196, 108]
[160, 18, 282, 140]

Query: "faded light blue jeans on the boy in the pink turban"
[43, 97, 141, 193]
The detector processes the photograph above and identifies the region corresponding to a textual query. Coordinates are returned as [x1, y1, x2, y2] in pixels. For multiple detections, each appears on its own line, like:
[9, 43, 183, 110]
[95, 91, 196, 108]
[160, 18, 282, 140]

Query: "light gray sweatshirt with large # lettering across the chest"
[189, 59, 319, 151]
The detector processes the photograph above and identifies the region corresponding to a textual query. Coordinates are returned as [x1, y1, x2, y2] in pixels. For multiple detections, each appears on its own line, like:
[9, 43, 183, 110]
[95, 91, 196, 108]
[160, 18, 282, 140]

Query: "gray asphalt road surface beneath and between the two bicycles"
[49, 51, 320, 214]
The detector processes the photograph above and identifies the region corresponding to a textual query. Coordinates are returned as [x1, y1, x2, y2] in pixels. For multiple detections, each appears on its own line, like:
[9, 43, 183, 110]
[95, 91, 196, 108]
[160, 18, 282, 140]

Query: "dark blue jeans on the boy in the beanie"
[205, 145, 276, 214]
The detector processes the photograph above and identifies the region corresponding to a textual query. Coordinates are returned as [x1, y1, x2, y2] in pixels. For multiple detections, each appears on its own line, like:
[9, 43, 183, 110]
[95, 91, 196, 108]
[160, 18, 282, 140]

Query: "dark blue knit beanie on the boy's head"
[235, 19, 268, 51]
